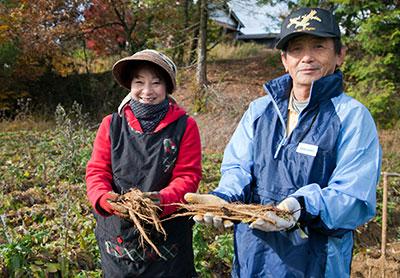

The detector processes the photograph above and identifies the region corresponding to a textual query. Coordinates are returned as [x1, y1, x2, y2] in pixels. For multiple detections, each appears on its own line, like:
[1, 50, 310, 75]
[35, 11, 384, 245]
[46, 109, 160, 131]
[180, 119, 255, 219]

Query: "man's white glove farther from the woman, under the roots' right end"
[250, 197, 301, 232]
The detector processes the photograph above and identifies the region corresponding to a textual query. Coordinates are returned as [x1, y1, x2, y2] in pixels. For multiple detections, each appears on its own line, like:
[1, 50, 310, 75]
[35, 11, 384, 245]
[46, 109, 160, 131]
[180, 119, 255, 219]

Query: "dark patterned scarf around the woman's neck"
[129, 99, 169, 132]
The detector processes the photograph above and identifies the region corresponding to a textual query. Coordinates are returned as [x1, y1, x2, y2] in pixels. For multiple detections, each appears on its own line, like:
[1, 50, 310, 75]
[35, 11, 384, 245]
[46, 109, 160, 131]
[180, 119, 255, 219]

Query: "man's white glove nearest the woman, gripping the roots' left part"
[184, 193, 233, 230]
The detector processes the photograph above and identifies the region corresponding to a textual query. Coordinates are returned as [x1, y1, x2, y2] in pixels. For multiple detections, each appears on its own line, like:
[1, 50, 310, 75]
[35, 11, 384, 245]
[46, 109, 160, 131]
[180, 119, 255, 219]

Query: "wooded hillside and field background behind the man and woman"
[0, 0, 400, 277]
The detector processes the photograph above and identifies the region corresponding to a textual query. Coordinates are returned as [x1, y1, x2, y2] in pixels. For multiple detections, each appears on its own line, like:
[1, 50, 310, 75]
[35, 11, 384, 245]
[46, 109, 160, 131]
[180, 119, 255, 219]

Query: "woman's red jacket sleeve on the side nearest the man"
[160, 117, 201, 217]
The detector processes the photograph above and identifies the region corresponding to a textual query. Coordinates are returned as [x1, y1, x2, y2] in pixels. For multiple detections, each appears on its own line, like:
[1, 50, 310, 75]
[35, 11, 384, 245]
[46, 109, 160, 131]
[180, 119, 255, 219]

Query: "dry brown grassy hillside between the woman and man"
[174, 49, 283, 152]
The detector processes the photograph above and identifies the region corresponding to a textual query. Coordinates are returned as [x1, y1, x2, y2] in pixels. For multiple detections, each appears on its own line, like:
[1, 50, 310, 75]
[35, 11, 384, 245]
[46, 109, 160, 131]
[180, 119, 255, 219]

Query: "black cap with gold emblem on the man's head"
[276, 8, 340, 49]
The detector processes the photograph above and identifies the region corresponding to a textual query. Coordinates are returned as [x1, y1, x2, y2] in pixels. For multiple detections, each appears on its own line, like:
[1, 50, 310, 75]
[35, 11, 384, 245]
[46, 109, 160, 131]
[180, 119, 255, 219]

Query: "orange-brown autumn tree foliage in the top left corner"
[0, 0, 85, 110]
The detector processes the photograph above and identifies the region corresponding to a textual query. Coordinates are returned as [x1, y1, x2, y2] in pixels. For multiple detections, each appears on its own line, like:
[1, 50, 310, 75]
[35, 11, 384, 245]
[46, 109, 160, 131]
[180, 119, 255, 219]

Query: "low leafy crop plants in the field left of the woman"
[0, 104, 100, 277]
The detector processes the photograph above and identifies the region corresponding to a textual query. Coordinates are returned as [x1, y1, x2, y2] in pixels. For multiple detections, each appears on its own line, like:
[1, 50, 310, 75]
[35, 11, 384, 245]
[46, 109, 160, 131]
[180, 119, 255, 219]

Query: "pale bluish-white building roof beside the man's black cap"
[229, 0, 288, 35]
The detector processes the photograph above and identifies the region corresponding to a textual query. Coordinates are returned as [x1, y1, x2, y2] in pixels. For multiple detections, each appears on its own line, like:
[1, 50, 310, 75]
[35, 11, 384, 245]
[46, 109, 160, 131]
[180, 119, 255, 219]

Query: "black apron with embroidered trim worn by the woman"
[95, 113, 197, 278]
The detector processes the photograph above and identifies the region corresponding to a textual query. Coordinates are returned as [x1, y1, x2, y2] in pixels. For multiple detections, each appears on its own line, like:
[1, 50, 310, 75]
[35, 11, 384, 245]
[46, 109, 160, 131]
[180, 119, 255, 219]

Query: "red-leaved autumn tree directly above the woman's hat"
[83, 0, 177, 54]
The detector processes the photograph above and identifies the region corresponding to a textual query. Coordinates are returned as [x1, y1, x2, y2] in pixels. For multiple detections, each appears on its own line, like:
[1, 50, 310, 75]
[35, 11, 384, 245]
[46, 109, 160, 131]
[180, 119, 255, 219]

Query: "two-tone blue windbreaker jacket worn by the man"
[212, 71, 381, 277]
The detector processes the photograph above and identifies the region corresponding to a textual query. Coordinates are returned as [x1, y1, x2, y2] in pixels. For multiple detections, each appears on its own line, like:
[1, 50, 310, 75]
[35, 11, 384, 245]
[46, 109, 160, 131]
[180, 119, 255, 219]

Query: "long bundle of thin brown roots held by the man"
[174, 203, 292, 225]
